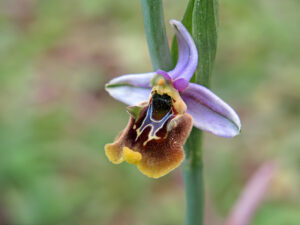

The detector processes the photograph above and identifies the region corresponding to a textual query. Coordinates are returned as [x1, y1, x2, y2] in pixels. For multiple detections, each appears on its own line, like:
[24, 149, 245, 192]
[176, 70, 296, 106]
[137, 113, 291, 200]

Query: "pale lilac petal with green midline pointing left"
[105, 72, 156, 105]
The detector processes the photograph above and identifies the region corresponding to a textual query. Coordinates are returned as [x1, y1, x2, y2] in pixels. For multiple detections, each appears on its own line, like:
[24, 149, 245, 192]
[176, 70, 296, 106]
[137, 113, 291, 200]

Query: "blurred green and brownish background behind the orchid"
[0, 0, 300, 225]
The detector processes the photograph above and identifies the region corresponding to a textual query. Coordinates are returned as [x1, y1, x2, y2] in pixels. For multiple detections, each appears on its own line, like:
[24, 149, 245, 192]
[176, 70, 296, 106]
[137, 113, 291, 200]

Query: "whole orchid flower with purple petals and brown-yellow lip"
[105, 20, 241, 178]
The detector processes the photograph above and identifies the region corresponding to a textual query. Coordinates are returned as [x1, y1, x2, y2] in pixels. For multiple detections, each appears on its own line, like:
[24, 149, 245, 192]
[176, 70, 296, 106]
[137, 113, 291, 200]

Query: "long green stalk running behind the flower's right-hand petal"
[183, 0, 217, 225]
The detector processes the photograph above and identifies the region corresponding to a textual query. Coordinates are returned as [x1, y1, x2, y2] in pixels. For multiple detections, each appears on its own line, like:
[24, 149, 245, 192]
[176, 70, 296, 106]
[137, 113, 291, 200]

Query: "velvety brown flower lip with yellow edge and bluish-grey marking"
[104, 102, 192, 178]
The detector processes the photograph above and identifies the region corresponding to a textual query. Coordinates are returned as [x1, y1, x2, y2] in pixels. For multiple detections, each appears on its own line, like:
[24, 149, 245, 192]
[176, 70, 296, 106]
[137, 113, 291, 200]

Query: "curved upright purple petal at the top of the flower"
[168, 20, 198, 81]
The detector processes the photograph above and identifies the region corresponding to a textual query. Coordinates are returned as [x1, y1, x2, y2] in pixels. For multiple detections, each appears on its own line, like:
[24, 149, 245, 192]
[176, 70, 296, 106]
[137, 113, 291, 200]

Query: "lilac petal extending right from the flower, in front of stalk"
[182, 83, 241, 138]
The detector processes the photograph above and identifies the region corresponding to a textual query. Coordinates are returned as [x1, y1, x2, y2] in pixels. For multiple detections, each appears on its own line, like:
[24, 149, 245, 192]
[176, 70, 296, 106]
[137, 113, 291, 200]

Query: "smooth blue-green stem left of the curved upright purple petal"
[142, 0, 172, 71]
